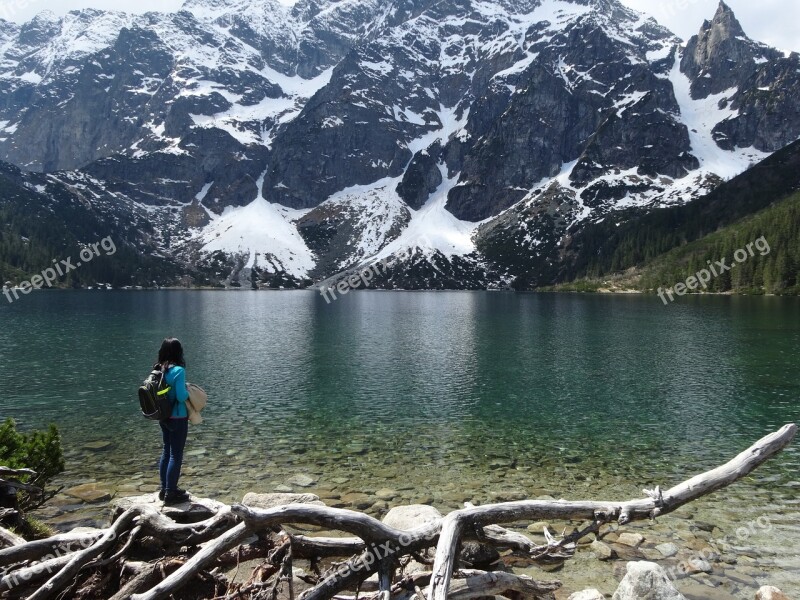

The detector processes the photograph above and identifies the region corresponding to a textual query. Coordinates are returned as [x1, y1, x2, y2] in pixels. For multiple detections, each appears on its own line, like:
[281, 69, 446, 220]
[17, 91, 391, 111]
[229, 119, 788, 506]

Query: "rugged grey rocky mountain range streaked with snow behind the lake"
[0, 0, 800, 288]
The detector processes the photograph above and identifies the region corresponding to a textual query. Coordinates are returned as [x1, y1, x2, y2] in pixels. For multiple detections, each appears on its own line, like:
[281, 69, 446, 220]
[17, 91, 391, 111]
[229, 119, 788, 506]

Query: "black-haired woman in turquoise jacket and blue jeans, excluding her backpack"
[158, 338, 189, 504]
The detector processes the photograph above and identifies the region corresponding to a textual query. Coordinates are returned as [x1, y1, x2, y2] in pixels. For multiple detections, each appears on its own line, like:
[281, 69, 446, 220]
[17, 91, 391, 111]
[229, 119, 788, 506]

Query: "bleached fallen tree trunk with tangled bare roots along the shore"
[0, 425, 797, 600]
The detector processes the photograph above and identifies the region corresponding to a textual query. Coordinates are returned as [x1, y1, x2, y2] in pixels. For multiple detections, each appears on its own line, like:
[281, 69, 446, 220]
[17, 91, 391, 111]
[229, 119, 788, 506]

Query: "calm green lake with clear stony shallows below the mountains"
[0, 291, 800, 592]
